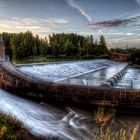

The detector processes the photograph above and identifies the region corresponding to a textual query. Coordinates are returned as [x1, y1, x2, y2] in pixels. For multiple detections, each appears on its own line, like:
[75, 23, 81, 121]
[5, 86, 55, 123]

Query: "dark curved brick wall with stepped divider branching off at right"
[0, 38, 140, 108]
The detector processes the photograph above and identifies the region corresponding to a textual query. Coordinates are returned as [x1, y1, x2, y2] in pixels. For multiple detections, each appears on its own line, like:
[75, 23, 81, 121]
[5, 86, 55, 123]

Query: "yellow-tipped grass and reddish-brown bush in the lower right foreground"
[94, 107, 139, 140]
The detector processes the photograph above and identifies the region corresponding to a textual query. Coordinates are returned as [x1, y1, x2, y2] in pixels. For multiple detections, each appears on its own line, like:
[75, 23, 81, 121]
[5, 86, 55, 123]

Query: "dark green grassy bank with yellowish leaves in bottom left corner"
[0, 113, 42, 140]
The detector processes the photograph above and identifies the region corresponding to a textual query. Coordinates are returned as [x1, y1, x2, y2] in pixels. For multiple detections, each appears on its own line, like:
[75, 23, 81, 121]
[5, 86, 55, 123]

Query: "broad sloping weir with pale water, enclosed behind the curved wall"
[17, 60, 127, 86]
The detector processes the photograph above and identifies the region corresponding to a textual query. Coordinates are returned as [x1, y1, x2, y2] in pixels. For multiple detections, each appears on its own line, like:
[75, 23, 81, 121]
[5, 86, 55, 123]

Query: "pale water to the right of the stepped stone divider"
[116, 67, 140, 89]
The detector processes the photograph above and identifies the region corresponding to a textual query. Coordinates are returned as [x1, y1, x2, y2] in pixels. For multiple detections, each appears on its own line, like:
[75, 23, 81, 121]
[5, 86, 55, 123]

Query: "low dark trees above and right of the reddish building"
[110, 48, 140, 64]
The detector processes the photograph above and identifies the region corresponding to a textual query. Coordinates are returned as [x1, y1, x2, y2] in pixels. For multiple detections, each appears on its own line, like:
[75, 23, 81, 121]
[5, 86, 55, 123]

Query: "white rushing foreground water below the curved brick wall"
[0, 90, 97, 140]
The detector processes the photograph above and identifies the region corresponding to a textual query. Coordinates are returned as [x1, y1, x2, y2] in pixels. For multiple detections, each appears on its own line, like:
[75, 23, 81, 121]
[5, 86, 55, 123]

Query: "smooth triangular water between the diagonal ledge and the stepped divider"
[59, 63, 127, 86]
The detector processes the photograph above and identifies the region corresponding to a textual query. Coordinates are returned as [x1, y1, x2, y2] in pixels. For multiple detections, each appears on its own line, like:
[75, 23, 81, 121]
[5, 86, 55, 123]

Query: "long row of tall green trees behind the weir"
[0, 31, 108, 60]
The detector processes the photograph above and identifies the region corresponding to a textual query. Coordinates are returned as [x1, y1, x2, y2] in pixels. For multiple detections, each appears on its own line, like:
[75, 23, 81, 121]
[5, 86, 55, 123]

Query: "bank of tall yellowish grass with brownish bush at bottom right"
[93, 107, 140, 140]
